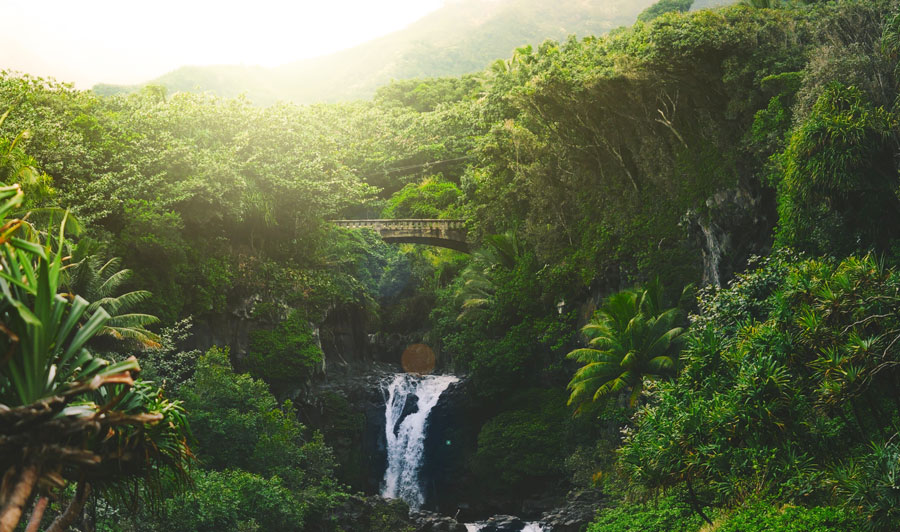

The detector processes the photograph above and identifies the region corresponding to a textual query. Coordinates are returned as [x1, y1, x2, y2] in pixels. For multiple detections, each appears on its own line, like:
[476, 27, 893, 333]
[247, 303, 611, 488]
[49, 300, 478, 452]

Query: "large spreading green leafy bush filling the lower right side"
[621, 252, 900, 530]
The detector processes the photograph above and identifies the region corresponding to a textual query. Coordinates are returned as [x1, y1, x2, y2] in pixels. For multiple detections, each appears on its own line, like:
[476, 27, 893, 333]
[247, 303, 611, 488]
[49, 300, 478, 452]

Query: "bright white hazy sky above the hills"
[0, 0, 444, 88]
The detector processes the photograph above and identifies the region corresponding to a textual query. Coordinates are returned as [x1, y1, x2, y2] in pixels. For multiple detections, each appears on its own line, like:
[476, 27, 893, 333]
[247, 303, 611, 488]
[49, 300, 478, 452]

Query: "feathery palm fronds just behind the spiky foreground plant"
[66, 239, 159, 347]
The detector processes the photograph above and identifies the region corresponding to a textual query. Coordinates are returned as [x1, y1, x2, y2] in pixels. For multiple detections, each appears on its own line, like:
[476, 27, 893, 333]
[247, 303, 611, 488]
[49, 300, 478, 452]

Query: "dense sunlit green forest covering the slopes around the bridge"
[0, 0, 900, 532]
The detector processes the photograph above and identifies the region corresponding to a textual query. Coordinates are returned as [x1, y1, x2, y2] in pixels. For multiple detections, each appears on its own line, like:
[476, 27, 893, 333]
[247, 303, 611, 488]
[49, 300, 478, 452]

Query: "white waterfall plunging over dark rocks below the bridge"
[381, 373, 459, 509]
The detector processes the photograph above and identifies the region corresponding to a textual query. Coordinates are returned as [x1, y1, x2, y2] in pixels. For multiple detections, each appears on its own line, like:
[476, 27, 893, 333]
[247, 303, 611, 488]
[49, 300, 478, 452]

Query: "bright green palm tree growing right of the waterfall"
[567, 280, 684, 414]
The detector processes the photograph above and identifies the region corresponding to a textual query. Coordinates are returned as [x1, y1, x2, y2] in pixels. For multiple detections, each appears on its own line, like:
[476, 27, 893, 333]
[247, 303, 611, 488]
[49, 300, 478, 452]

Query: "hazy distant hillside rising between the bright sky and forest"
[94, 0, 655, 105]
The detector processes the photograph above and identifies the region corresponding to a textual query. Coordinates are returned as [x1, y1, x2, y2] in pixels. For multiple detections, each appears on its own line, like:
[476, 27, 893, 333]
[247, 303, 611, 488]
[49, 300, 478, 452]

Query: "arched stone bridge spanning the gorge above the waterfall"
[332, 219, 469, 253]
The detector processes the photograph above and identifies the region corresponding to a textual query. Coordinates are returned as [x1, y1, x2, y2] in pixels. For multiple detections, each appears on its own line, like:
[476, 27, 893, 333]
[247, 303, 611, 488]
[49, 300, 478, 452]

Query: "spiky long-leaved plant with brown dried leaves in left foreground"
[0, 185, 191, 532]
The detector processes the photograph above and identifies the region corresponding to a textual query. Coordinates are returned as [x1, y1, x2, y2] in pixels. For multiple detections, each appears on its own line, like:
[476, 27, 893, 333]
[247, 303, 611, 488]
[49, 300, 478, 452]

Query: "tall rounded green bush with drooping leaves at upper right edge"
[777, 82, 900, 256]
